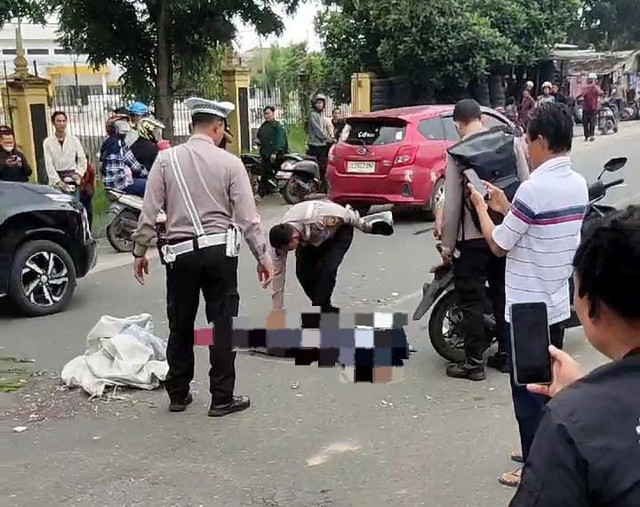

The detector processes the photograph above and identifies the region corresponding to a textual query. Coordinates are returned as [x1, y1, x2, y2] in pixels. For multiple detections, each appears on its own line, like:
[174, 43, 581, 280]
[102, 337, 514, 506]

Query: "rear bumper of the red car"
[328, 166, 437, 206]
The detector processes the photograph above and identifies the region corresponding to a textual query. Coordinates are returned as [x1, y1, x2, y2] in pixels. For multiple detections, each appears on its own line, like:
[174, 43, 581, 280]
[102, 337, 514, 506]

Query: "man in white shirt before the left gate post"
[43, 111, 87, 189]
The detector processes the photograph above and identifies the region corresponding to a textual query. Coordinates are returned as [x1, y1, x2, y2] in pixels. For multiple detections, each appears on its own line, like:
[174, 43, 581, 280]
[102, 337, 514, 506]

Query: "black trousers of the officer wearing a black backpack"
[453, 239, 509, 361]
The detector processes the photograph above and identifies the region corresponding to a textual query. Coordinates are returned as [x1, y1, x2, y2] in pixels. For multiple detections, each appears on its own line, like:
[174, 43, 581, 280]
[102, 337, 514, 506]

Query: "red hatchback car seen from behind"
[327, 106, 516, 218]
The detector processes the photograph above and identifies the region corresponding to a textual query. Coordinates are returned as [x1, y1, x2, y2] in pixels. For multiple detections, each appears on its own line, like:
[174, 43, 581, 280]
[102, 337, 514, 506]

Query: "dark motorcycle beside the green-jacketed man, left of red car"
[240, 153, 321, 204]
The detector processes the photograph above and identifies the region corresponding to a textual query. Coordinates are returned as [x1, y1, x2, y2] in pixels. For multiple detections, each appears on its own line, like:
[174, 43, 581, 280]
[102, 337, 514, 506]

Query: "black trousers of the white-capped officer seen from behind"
[165, 245, 240, 405]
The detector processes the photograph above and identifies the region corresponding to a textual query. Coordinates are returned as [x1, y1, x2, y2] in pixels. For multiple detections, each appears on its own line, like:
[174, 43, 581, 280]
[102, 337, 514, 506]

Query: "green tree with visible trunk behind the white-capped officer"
[49, 0, 298, 137]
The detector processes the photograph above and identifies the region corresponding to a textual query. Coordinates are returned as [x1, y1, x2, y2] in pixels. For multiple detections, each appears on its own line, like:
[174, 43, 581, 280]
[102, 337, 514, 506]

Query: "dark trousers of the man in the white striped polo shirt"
[508, 324, 564, 462]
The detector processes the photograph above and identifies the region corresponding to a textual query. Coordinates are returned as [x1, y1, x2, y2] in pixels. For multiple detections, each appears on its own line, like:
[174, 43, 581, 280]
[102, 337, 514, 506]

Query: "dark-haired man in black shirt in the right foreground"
[511, 206, 640, 507]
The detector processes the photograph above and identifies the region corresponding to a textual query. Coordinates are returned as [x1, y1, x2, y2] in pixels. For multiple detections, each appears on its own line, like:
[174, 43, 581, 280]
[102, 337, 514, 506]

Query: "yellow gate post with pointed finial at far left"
[7, 23, 50, 184]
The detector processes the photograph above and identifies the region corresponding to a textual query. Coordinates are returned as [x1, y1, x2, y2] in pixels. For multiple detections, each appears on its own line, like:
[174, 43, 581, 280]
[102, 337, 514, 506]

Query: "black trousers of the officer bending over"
[296, 225, 353, 310]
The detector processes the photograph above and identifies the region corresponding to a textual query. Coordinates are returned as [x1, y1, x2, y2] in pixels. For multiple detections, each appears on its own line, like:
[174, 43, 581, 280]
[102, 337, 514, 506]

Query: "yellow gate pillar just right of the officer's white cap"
[222, 54, 251, 156]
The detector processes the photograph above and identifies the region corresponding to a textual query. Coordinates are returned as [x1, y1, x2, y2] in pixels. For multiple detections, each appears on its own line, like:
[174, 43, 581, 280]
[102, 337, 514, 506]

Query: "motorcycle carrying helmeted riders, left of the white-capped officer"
[107, 189, 167, 252]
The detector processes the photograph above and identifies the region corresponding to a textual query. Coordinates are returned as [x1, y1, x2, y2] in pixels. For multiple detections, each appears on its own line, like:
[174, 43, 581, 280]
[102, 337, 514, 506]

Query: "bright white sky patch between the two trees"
[236, 0, 320, 53]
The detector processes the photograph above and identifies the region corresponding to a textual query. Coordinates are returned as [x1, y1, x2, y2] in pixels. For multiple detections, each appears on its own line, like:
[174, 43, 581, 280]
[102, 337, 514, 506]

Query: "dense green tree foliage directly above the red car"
[316, 0, 579, 97]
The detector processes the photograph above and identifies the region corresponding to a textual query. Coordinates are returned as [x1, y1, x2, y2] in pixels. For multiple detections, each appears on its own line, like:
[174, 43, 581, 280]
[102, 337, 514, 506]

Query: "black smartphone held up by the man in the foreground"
[511, 303, 553, 386]
